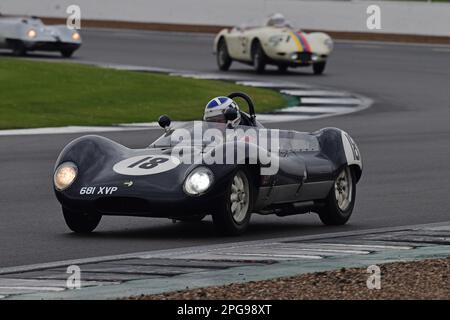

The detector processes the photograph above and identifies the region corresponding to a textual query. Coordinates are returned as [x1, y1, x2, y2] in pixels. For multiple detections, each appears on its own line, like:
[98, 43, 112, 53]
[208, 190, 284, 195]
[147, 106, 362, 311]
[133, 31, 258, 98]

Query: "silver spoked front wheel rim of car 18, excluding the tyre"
[230, 171, 250, 224]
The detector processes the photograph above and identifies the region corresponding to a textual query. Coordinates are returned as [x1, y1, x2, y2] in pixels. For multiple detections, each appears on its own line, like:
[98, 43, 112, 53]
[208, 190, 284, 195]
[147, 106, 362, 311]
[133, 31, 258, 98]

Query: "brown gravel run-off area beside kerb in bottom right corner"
[132, 257, 450, 300]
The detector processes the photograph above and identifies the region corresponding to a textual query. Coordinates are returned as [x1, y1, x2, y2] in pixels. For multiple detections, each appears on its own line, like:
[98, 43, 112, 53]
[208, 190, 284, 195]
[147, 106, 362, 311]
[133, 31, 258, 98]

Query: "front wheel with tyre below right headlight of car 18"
[213, 169, 253, 235]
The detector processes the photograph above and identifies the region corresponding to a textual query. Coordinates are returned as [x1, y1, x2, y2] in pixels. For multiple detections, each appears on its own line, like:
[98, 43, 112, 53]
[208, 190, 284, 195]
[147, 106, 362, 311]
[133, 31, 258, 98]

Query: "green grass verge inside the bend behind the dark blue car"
[0, 58, 286, 129]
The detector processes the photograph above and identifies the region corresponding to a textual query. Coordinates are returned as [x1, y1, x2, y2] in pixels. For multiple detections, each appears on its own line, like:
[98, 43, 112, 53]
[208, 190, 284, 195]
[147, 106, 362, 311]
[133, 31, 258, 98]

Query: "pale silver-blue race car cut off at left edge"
[0, 15, 81, 57]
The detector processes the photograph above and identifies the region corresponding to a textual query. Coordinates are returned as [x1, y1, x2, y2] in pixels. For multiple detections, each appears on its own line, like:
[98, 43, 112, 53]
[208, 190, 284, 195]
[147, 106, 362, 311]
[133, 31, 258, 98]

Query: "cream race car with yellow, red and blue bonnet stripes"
[214, 14, 333, 74]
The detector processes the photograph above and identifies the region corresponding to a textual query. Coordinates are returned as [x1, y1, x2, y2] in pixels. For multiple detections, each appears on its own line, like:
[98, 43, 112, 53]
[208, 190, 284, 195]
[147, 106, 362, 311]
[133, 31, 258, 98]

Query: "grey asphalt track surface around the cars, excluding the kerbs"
[0, 30, 450, 267]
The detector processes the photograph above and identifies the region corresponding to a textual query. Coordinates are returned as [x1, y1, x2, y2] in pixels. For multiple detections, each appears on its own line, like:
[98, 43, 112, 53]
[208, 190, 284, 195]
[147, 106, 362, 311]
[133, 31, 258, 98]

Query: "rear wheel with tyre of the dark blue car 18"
[319, 166, 356, 225]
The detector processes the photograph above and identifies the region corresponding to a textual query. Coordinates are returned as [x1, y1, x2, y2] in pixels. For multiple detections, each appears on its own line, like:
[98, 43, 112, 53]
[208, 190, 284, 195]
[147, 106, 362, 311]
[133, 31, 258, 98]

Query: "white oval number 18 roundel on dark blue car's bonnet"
[113, 155, 181, 176]
